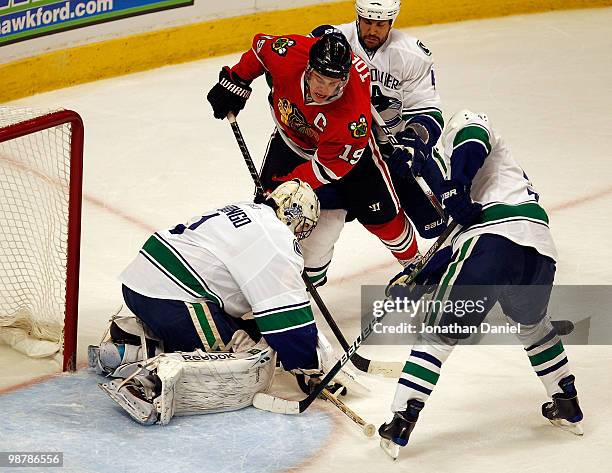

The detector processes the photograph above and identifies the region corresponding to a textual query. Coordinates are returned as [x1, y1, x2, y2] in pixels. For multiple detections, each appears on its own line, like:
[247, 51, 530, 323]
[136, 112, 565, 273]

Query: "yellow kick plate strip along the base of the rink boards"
[0, 0, 612, 102]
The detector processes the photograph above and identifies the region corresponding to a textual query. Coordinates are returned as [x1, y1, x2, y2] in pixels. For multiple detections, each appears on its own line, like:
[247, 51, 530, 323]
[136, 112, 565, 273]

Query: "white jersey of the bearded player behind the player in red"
[334, 21, 444, 143]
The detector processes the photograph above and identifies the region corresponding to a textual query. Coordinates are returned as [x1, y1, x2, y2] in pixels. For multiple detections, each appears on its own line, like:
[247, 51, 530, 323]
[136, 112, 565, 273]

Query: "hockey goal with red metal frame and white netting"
[0, 106, 83, 371]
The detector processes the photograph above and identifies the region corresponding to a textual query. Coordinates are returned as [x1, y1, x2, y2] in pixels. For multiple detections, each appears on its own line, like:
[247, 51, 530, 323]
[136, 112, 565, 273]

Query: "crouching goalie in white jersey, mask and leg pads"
[90, 179, 364, 424]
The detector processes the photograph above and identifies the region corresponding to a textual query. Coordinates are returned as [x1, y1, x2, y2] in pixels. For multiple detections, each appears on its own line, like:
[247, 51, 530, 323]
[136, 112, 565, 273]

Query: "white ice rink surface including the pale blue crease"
[0, 8, 612, 473]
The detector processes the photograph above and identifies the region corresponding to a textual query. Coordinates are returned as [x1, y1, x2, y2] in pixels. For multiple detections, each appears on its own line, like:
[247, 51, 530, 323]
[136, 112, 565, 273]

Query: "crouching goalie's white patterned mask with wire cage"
[268, 179, 321, 240]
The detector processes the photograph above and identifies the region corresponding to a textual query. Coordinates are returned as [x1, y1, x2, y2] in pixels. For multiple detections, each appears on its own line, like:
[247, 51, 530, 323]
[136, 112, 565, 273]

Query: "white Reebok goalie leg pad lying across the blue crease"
[99, 338, 276, 425]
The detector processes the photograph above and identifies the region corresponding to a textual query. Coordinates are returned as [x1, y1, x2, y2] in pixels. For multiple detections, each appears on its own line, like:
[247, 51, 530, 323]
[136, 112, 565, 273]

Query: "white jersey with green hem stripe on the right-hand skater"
[440, 112, 557, 260]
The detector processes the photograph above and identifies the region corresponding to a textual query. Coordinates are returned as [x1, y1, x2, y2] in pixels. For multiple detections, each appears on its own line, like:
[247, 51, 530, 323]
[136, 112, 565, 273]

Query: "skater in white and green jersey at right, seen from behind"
[379, 110, 582, 458]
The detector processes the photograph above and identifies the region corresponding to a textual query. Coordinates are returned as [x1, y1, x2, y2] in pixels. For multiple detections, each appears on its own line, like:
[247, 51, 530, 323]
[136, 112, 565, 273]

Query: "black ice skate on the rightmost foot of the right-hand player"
[542, 375, 584, 435]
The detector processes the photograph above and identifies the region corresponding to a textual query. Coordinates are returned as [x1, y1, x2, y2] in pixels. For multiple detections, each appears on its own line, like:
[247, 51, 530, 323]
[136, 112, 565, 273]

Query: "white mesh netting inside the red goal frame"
[0, 107, 71, 356]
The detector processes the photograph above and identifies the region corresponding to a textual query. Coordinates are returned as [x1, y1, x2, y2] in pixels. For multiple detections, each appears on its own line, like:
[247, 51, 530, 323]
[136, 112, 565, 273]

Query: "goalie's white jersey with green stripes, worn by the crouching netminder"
[120, 203, 314, 334]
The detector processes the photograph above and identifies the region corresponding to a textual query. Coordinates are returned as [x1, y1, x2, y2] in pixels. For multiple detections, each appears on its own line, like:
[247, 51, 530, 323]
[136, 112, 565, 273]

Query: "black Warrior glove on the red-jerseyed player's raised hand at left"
[206, 66, 251, 120]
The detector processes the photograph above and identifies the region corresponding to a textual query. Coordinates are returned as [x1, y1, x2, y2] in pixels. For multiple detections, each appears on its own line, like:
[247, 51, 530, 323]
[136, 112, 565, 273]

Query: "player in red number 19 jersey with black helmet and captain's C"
[208, 33, 418, 284]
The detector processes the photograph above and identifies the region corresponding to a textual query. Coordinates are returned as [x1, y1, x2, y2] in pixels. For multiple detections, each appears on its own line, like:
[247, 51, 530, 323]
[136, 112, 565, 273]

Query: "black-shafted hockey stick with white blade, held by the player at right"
[253, 222, 457, 414]
